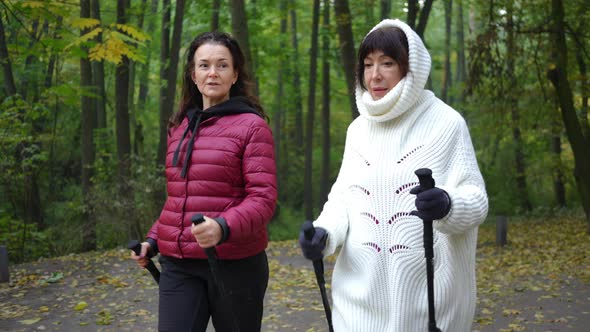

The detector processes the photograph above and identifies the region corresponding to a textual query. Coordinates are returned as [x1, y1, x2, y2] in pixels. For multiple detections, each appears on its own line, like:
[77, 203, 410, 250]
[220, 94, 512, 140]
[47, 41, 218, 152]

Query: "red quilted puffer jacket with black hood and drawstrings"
[147, 98, 277, 259]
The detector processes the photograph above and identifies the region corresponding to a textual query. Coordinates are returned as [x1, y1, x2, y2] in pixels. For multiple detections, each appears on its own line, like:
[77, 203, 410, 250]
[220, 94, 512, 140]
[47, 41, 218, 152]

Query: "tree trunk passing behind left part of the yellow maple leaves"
[80, 0, 96, 251]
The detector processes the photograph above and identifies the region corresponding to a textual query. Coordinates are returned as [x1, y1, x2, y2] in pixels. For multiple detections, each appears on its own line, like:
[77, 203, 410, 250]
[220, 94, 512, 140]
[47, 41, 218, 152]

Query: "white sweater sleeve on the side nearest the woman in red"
[314, 127, 351, 256]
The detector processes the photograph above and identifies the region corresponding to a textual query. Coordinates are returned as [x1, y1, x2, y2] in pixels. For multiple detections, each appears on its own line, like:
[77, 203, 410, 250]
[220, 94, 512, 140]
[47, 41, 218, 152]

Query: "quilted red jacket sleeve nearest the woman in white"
[220, 120, 278, 241]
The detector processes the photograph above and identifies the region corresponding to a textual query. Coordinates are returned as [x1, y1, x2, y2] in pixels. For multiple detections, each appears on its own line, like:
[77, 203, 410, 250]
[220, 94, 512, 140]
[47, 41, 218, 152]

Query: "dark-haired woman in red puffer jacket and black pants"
[132, 32, 277, 331]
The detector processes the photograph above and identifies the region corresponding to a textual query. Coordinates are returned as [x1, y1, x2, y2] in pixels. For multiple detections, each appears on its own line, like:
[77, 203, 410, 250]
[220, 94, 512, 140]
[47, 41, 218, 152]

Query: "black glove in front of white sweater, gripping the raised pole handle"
[410, 186, 451, 220]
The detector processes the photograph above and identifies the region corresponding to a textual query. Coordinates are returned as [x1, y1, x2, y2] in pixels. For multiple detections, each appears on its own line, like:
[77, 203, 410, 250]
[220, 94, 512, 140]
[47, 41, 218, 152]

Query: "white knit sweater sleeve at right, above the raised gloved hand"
[433, 119, 488, 234]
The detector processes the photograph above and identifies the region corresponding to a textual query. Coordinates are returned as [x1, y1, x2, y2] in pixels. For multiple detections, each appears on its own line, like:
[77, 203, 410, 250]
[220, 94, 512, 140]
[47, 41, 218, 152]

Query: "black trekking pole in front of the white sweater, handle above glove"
[415, 168, 441, 332]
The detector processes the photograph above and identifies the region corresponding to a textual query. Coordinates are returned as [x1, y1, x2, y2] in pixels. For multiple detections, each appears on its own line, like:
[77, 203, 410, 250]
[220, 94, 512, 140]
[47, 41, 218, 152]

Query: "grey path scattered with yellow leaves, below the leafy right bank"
[0, 241, 590, 332]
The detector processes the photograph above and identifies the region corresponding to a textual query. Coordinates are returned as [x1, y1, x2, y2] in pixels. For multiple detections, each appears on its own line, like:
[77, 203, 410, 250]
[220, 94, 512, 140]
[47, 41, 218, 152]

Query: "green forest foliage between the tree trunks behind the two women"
[0, 0, 590, 260]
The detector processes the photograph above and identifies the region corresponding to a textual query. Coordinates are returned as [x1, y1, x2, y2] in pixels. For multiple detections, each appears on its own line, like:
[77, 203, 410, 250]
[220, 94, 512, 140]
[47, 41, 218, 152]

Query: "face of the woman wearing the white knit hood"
[364, 50, 402, 100]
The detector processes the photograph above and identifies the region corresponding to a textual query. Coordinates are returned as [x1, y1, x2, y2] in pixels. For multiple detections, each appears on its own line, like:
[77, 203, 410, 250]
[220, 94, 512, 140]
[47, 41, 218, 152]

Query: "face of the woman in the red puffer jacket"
[191, 44, 238, 109]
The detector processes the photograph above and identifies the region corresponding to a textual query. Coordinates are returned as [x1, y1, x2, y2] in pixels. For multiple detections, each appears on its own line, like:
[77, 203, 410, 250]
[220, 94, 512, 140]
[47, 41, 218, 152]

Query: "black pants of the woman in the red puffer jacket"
[158, 251, 268, 332]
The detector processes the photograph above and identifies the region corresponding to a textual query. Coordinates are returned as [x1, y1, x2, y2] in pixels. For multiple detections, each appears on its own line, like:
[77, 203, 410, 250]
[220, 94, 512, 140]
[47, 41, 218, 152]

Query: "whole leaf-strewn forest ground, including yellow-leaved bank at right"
[0, 217, 590, 332]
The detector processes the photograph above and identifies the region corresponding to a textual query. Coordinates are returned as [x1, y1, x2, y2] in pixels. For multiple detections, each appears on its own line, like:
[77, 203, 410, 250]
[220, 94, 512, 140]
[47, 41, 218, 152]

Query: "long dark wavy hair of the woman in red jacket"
[168, 31, 268, 128]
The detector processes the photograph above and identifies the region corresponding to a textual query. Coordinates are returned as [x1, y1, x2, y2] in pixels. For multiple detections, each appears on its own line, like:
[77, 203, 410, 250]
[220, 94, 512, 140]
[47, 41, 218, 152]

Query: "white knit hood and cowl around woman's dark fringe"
[355, 19, 431, 122]
